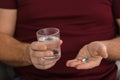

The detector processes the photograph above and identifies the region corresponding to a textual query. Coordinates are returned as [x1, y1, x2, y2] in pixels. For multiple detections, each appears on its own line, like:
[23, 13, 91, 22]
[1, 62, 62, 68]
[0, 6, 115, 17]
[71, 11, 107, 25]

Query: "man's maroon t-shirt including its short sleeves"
[0, 0, 120, 80]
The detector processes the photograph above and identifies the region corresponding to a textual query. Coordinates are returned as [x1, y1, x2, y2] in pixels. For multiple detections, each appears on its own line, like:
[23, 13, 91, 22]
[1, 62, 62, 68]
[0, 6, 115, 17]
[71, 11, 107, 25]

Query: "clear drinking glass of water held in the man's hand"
[36, 28, 61, 60]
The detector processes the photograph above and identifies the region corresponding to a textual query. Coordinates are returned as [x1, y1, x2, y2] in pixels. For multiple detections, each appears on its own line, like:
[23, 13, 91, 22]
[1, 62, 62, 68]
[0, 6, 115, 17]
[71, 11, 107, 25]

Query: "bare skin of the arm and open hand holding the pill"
[66, 19, 120, 69]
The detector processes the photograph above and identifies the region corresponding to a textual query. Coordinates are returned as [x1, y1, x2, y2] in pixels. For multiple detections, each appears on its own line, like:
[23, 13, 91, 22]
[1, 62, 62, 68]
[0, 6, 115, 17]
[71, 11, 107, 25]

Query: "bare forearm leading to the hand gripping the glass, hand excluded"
[0, 34, 31, 66]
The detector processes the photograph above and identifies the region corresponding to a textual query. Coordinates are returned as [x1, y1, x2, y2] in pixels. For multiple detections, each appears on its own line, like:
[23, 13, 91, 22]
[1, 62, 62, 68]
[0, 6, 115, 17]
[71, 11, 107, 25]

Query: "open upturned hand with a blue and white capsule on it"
[67, 42, 107, 69]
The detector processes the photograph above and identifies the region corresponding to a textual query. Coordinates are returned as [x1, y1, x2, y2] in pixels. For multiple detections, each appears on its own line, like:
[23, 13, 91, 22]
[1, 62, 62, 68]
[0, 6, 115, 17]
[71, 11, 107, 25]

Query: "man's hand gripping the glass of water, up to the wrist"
[30, 42, 58, 70]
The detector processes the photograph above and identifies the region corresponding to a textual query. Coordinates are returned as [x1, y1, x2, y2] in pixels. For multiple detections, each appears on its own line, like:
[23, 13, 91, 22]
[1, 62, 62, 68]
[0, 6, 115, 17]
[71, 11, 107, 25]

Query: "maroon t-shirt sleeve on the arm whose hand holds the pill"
[112, 0, 120, 18]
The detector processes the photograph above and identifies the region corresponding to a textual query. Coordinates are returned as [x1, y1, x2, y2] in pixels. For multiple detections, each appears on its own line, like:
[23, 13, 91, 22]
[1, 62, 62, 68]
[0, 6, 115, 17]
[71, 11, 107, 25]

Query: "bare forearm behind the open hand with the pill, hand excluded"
[103, 37, 120, 60]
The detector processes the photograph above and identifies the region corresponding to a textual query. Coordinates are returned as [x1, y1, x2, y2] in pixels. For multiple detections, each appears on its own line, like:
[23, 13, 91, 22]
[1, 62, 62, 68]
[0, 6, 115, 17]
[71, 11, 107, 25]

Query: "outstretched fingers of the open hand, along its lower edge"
[66, 56, 102, 69]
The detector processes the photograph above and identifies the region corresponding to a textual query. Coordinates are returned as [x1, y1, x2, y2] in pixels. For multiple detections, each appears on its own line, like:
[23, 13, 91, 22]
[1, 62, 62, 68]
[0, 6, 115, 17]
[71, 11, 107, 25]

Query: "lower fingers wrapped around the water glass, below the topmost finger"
[31, 51, 57, 69]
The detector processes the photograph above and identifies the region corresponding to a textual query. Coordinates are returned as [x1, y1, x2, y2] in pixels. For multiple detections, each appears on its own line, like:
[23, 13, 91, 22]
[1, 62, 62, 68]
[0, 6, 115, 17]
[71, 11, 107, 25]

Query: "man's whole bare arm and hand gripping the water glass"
[0, 9, 62, 69]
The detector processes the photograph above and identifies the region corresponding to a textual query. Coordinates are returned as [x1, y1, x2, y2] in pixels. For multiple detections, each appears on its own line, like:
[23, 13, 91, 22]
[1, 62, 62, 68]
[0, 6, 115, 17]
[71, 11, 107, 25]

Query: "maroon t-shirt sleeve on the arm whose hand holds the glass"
[0, 0, 17, 9]
